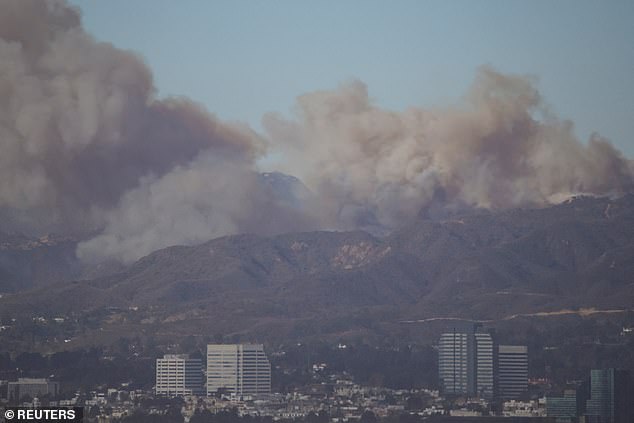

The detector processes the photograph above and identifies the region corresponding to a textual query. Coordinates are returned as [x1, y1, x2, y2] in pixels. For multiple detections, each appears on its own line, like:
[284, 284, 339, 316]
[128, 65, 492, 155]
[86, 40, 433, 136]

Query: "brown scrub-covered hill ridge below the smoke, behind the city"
[0, 195, 634, 346]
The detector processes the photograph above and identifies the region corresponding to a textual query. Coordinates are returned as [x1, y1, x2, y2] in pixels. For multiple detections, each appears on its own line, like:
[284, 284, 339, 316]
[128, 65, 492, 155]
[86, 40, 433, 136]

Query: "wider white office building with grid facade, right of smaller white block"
[207, 344, 271, 395]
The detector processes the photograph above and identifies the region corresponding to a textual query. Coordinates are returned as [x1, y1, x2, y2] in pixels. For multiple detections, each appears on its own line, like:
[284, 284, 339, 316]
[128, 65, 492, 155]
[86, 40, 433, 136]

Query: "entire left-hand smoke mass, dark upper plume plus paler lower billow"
[0, 0, 308, 261]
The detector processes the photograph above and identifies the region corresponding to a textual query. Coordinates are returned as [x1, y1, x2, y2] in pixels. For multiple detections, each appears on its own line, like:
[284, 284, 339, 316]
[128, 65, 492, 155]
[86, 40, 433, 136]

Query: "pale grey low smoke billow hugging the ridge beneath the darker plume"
[78, 153, 308, 262]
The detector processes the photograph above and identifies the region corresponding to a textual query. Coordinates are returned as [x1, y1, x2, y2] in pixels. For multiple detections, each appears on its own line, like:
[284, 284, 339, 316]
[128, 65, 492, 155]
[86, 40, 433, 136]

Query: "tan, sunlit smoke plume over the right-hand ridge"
[264, 71, 634, 228]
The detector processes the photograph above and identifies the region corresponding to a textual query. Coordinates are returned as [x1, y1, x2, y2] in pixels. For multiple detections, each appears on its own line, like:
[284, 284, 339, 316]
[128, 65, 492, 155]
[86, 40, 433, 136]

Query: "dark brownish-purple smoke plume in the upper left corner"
[0, 0, 257, 224]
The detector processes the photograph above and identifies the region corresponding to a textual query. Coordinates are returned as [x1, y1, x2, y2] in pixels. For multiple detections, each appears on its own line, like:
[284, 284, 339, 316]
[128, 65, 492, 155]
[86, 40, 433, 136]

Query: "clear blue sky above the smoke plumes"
[72, 0, 634, 158]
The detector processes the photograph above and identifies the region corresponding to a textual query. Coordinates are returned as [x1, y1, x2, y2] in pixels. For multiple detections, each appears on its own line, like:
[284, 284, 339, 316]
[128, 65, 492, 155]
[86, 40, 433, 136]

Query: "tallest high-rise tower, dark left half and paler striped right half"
[438, 325, 495, 398]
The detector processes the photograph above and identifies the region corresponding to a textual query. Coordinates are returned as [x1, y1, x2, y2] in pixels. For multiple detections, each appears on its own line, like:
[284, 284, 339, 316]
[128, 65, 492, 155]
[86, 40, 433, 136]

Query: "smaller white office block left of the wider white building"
[155, 354, 204, 396]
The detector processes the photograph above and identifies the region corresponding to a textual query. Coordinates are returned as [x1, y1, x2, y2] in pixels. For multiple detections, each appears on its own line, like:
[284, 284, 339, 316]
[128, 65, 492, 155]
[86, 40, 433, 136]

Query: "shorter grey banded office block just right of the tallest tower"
[497, 345, 528, 399]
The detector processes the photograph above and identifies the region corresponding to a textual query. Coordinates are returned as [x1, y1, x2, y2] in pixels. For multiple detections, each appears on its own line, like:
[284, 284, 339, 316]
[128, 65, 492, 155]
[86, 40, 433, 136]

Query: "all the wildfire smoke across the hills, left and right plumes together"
[0, 0, 634, 262]
